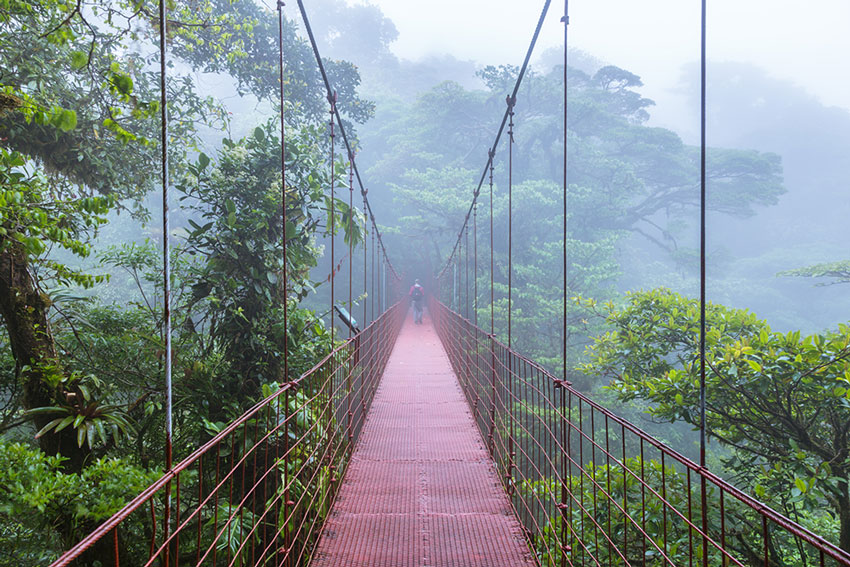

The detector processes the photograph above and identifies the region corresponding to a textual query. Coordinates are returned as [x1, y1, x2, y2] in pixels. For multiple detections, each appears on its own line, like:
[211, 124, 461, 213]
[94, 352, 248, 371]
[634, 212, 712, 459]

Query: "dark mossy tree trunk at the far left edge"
[0, 242, 87, 472]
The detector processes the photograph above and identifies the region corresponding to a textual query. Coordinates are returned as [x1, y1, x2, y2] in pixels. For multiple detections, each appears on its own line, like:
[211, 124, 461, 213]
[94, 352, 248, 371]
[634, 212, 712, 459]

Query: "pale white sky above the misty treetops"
[330, 0, 850, 117]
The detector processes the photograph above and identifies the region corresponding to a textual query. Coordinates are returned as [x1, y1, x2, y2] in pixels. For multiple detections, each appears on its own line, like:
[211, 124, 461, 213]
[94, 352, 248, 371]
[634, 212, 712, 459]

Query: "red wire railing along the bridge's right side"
[430, 300, 850, 567]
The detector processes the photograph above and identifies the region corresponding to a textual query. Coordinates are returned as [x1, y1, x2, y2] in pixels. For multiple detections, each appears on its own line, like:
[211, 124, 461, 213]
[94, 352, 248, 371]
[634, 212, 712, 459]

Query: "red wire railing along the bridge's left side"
[53, 303, 407, 567]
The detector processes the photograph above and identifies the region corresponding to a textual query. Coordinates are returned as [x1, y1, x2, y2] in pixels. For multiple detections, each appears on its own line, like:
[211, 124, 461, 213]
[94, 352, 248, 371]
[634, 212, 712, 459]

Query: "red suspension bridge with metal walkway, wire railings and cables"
[48, 0, 850, 567]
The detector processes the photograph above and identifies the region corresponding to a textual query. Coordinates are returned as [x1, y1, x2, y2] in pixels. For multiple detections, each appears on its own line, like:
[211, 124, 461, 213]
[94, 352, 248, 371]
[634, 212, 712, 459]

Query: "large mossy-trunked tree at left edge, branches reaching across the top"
[0, 1, 371, 470]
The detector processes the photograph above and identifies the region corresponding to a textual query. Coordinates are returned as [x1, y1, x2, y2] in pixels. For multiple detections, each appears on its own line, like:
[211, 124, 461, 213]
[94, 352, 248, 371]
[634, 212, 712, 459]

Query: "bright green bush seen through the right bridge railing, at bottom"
[518, 457, 829, 567]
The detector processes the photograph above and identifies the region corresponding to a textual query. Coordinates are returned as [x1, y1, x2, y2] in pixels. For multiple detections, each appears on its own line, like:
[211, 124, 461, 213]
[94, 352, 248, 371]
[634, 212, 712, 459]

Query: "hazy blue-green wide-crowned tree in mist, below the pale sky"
[374, 62, 784, 248]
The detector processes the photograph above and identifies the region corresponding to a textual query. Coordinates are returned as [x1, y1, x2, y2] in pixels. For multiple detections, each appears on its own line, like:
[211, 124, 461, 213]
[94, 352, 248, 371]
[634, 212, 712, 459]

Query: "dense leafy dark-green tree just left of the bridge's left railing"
[179, 124, 362, 408]
